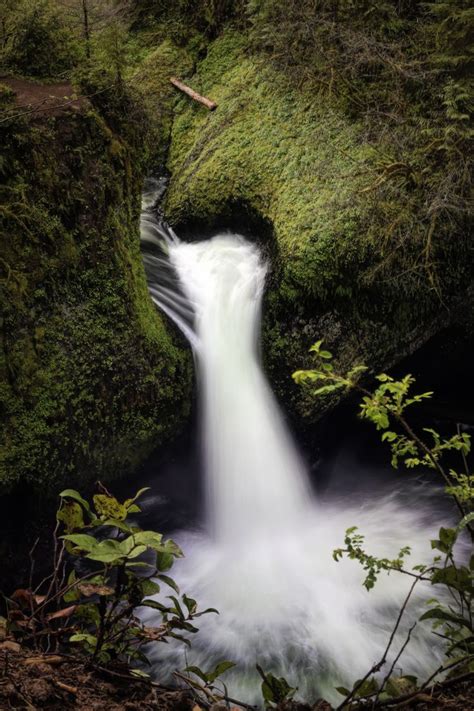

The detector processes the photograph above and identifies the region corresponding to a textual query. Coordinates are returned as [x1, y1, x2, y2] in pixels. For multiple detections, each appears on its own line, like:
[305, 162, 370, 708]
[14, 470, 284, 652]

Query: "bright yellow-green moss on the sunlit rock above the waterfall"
[166, 33, 374, 296]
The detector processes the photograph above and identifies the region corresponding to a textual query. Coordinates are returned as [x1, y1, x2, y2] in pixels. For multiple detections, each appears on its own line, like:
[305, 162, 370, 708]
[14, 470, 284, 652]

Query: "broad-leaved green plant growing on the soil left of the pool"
[8, 486, 217, 675]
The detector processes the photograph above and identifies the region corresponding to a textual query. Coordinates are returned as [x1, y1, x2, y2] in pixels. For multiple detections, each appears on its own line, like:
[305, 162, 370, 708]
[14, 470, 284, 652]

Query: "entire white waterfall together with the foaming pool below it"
[140, 197, 444, 702]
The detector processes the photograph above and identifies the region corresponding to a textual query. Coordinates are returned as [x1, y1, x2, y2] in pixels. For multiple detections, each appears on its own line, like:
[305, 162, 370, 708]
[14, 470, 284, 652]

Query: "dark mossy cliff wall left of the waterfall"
[0, 82, 191, 493]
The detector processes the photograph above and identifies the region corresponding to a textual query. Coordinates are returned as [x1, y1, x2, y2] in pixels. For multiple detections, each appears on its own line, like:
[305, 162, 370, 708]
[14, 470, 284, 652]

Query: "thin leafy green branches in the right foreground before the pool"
[293, 341, 474, 709]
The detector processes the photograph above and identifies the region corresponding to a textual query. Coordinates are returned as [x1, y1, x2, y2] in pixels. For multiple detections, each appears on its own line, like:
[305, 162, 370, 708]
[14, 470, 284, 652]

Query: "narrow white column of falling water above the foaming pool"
[169, 235, 310, 542]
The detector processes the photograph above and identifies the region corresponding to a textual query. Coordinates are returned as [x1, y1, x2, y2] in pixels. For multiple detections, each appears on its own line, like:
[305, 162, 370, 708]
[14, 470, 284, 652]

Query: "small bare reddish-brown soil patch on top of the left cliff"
[0, 76, 88, 116]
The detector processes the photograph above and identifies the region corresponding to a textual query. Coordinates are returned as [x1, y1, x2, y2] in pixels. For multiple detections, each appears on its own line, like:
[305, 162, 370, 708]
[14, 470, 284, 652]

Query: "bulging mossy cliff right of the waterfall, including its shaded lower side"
[157, 30, 472, 416]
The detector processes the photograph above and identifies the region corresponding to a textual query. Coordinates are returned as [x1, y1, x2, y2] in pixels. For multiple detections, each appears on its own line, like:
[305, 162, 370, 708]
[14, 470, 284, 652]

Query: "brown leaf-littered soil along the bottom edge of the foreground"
[0, 641, 474, 711]
